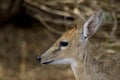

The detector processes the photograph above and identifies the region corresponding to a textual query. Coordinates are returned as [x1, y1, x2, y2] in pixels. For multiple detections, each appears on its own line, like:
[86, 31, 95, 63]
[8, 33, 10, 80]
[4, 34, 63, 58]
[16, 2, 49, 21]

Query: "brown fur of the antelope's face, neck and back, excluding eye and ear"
[41, 10, 120, 80]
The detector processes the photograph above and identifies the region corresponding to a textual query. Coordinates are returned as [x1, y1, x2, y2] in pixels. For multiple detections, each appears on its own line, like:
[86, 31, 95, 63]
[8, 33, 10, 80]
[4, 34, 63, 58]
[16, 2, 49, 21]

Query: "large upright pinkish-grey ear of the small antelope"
[82, 10, 103, 39]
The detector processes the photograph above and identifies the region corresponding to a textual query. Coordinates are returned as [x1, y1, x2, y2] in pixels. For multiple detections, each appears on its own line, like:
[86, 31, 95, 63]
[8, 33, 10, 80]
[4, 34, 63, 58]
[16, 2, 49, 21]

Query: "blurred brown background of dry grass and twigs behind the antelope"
[0, 0, 120, 80]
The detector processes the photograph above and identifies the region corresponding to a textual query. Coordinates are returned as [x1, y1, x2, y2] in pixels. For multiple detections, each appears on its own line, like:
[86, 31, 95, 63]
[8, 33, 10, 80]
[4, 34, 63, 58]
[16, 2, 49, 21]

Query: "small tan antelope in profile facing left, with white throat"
[38, 10, 120, 80]
